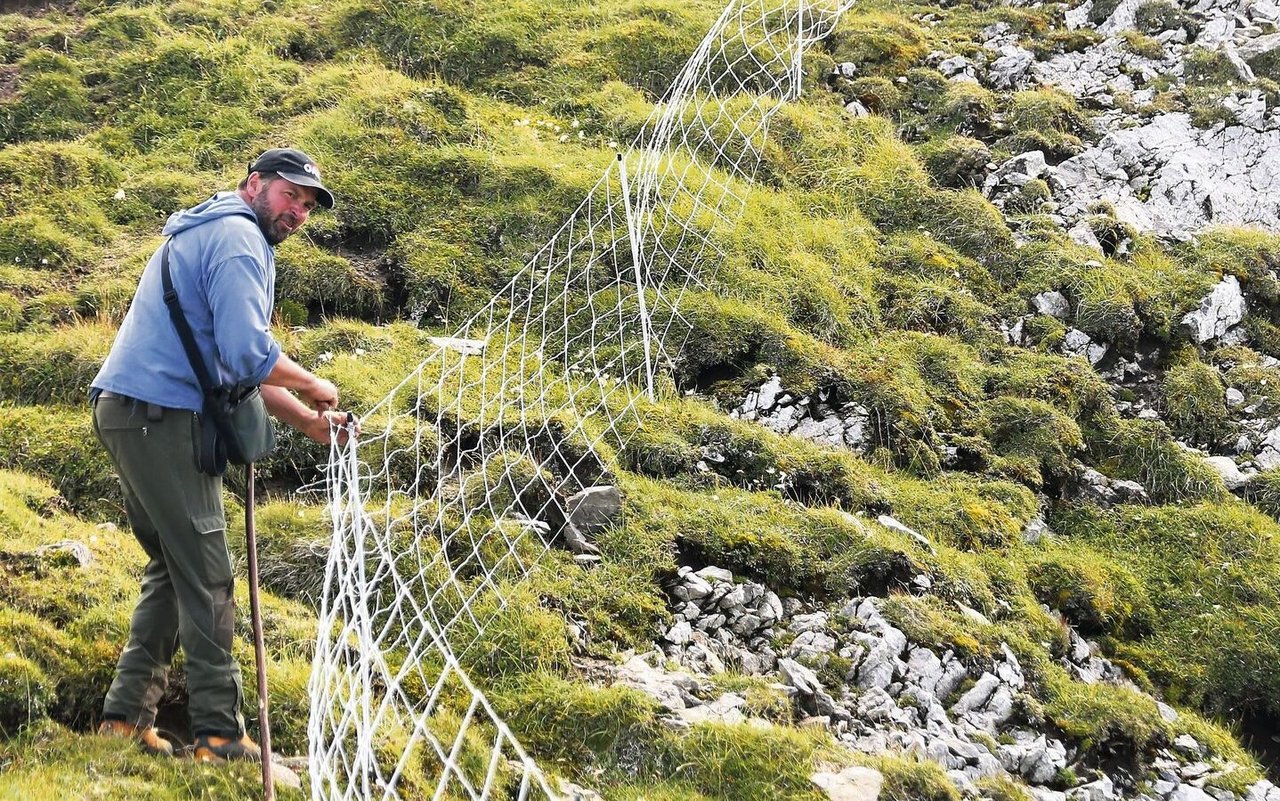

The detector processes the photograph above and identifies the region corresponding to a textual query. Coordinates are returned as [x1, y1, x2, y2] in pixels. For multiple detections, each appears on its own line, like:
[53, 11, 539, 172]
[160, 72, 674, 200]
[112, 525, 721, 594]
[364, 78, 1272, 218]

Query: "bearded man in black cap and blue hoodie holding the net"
[91, 148, 347, 761]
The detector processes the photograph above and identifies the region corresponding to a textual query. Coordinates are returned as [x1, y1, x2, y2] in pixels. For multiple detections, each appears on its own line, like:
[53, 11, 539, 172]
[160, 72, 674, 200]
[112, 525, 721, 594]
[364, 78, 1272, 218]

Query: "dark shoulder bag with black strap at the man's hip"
[160, 242, 275, 476]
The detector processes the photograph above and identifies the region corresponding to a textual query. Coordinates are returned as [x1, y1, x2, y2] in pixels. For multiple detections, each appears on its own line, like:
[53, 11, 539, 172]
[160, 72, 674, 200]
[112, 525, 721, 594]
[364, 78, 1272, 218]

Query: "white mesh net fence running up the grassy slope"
[310, 0, 849, 800]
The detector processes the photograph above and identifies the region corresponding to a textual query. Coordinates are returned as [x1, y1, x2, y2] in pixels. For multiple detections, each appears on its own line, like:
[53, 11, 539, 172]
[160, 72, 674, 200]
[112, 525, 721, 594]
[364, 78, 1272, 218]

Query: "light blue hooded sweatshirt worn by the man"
[92, 192, 280, 412]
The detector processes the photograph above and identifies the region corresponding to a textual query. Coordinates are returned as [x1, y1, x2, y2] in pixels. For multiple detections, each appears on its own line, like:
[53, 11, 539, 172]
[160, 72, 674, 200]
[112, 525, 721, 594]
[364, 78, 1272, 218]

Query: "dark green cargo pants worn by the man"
[93, 397, 244, 737]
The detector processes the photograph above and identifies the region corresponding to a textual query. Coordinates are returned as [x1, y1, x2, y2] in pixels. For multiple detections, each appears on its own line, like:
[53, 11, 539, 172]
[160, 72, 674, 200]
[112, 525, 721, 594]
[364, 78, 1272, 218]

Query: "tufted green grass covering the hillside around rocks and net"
[0, 0, 1280, 801]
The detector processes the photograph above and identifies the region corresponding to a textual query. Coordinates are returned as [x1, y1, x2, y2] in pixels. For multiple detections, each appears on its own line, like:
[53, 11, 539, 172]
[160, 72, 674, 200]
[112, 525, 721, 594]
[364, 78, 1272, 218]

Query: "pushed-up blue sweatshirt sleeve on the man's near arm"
[206, 255, 280, 385]
